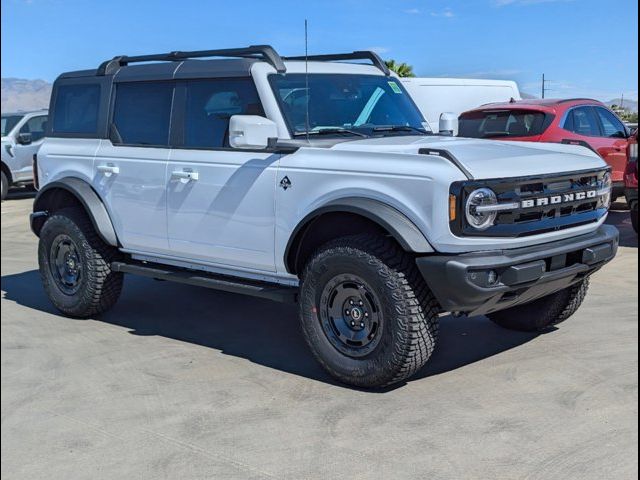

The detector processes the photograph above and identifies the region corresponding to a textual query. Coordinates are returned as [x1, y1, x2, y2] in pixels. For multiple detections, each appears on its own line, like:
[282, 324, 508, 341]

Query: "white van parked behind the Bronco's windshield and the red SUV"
[401, 77, 521, 135]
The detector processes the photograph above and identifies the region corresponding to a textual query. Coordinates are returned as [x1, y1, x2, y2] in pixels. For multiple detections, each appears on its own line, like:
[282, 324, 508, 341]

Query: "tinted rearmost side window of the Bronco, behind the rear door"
[53, 84, 100, 135]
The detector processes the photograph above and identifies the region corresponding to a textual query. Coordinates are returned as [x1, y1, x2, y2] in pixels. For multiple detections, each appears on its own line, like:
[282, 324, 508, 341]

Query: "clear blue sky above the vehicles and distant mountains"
[0, 0, 638, 100]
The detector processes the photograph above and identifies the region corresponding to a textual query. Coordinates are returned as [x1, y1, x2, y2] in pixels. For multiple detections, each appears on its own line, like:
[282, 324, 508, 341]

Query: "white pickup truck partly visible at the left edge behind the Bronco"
[0, 110, 47, 200]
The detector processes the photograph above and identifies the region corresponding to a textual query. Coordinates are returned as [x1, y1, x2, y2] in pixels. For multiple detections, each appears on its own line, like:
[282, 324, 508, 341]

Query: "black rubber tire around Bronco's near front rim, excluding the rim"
[300, 234, 440, 388]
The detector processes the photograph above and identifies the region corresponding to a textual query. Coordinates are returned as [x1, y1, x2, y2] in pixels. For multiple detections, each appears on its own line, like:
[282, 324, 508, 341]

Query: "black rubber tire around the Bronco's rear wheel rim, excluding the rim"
[38, 208, 123, 318]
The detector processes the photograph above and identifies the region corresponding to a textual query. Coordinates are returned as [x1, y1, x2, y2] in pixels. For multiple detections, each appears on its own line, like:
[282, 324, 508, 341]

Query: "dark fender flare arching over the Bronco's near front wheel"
[284, 197, 435, 272]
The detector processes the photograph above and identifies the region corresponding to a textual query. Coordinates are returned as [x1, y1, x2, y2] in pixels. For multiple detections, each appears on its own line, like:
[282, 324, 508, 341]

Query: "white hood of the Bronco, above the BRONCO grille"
[332, 136, 607, 179]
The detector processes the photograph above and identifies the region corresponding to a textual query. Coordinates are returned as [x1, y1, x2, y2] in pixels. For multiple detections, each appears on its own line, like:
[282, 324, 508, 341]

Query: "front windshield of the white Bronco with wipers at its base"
[270, 74, 427, 136]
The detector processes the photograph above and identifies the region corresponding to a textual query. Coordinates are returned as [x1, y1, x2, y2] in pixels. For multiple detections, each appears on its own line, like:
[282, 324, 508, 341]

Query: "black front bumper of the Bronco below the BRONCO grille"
[416, 225, 619, 315]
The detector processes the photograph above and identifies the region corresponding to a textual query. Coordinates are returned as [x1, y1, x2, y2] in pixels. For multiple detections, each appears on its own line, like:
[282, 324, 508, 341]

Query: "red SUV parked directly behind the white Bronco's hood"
[458, 98, 631, 199]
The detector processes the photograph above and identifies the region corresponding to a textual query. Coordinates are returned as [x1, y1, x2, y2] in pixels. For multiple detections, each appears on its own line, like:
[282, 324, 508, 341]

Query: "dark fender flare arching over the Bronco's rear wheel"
[30, 177, 119, 247]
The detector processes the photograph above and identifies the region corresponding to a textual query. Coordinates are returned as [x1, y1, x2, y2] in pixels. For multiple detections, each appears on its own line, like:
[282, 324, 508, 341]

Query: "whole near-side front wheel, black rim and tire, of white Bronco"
[300, 235, 439, 388]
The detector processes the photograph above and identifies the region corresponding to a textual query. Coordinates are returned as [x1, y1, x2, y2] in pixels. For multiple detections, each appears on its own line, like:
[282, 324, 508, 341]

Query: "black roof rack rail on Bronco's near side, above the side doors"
[97, 45, 287, 75]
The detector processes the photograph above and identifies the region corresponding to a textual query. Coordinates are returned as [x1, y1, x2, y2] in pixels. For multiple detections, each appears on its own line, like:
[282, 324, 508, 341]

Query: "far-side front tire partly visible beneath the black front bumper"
[488, 278, 589, 332]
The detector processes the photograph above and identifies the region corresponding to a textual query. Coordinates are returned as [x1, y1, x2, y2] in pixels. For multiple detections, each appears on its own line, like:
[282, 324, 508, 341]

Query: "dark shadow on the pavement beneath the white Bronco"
[1, 270, 536, 392]
